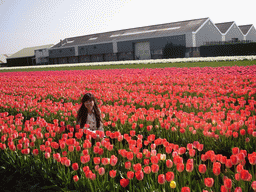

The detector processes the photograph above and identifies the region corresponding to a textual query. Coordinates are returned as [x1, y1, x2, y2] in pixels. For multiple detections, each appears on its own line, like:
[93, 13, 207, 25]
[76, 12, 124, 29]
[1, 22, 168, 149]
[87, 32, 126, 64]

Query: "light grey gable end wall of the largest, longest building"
[195, 20, 222, 47]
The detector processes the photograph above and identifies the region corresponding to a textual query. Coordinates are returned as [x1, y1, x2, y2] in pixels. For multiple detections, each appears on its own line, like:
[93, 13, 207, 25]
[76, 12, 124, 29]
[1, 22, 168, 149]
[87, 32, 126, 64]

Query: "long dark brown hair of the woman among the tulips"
[77, 93, 101, 128]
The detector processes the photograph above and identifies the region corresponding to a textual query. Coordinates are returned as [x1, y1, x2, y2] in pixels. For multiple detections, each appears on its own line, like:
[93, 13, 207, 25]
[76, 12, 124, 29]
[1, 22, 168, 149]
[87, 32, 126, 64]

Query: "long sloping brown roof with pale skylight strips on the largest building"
[52, 17, 209, 48]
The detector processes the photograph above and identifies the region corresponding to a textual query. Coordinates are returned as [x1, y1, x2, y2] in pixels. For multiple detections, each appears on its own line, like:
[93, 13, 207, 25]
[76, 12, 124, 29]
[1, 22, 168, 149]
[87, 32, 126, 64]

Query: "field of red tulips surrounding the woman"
[0, 65, 256, 192]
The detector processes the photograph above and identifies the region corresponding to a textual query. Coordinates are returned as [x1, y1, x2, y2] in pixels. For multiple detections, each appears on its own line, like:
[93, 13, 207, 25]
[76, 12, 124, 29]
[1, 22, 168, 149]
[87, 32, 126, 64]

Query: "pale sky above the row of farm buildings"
[0, 0, 256, 54]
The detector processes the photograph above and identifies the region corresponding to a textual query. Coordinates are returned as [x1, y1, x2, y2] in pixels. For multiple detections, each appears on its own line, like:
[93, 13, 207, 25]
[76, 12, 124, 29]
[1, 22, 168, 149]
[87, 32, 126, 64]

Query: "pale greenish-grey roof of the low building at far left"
[8, 44, 53, 59]
